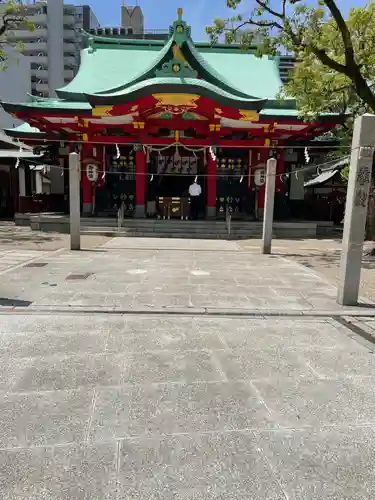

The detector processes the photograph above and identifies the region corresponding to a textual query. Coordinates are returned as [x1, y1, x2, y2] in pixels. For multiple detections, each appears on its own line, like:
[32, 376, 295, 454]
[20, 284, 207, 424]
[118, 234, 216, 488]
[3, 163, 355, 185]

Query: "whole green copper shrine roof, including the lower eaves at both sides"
[4, 10, 326, 122]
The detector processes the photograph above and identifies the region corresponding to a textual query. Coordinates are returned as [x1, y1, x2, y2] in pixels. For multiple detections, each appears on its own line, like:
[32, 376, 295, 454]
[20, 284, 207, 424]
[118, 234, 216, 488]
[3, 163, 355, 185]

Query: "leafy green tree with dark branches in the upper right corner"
[207, 0, 375, 117]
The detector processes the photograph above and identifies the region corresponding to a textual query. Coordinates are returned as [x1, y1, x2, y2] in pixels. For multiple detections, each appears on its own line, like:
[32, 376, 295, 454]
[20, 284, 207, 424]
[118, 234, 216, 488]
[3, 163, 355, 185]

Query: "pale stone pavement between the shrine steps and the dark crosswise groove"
[0, 238, 370, 314]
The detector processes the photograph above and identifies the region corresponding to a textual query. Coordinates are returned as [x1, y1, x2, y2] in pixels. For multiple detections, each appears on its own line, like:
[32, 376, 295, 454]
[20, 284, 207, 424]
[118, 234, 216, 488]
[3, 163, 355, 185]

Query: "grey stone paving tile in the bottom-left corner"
[0, 448, 53, 500]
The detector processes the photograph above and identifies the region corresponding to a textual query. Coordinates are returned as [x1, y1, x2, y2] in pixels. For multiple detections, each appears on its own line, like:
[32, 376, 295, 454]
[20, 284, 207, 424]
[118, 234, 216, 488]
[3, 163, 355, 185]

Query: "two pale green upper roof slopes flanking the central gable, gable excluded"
[57, 42, 281, 100]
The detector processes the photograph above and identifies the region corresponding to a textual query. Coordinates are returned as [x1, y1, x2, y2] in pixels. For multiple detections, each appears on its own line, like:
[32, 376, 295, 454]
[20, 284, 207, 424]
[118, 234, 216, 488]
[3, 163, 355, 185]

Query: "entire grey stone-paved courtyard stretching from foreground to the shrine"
[0, 239, 375, 500]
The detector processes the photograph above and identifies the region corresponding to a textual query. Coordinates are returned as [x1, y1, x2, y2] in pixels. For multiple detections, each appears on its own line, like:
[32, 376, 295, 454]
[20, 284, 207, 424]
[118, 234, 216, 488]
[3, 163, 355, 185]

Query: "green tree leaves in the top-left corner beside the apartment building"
[0, 0, 34, 70]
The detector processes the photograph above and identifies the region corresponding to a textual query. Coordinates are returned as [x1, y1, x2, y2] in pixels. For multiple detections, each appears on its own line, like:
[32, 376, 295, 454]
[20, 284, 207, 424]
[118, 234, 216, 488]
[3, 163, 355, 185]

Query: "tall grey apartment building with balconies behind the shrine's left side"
[0, 0, 99, 97]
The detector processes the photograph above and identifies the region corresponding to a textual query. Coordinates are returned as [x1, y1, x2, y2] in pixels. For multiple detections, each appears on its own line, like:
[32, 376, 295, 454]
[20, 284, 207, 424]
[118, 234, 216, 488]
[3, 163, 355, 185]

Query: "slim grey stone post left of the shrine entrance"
[69, 149, 81, 250]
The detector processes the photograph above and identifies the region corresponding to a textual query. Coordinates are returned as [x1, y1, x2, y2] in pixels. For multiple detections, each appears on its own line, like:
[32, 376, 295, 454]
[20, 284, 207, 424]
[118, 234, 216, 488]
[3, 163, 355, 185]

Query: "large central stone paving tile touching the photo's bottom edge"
[119, 433, 285, 500]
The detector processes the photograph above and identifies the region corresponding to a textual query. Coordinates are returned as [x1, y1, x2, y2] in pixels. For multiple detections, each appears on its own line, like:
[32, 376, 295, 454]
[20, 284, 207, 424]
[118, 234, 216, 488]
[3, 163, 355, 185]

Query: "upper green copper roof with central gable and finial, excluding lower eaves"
[56, 9, 282, 104]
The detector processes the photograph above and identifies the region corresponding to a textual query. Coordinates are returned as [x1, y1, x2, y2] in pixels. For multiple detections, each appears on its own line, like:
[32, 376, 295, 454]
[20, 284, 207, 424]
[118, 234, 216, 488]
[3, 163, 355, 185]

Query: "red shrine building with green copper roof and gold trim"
[2, 9, 338, 218]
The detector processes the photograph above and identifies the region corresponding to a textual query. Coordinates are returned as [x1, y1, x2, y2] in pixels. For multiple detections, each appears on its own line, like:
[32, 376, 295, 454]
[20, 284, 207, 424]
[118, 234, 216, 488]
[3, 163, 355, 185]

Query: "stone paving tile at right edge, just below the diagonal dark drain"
[299, 343, 375, 377]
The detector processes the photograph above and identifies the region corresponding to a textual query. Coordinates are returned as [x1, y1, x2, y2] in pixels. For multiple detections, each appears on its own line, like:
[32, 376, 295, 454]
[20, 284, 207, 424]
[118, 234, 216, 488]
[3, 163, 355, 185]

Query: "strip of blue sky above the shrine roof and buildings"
[65, 0, 366, 40]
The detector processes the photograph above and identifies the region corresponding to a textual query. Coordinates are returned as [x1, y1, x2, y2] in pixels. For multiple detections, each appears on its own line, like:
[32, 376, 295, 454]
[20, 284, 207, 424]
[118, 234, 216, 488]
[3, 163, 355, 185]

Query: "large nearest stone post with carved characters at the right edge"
[337, 114, 375, 306]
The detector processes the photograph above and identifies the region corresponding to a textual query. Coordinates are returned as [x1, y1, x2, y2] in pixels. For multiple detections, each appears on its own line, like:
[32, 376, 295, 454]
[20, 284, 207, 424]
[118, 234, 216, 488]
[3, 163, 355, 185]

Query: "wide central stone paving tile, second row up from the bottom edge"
[90, 382, 273, 440]
